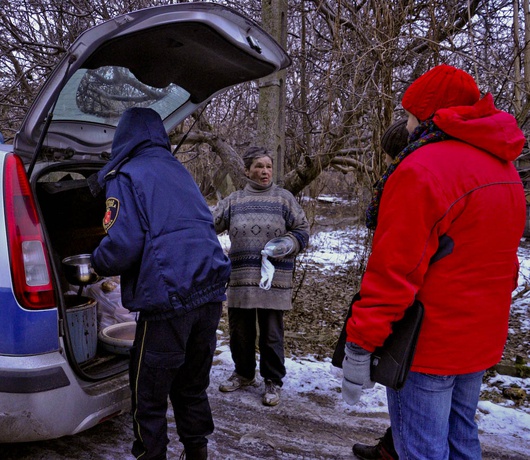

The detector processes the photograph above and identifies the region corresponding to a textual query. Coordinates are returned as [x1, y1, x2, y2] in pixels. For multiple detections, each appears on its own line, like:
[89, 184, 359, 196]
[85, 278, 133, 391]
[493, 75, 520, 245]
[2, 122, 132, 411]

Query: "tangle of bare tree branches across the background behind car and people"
[0, 0, 530, 208]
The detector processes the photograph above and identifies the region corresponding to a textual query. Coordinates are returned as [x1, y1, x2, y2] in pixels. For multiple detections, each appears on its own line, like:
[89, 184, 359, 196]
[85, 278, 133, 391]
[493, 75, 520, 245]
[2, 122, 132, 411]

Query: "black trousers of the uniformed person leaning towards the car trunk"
[129, 302, 222, 460]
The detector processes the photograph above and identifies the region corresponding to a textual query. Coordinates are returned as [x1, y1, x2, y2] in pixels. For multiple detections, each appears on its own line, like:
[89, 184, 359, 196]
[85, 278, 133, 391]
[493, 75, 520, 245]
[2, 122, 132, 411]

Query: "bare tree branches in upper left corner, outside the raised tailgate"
[0, 0, 151, 139]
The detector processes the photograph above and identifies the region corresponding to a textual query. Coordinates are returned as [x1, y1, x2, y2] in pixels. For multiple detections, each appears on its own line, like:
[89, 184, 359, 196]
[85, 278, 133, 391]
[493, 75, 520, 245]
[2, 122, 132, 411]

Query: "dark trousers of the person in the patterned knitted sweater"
[228, 308, 285, 386]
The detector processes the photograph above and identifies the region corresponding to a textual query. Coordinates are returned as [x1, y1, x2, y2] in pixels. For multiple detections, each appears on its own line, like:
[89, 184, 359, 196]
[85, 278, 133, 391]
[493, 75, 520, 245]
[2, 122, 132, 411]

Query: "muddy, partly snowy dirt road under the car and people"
[0, 363, 530, 460]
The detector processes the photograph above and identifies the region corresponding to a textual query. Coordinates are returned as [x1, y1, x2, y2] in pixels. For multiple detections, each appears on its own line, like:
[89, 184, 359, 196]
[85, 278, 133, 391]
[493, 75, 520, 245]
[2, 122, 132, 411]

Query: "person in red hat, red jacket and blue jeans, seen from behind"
[343, 64, 526, 460]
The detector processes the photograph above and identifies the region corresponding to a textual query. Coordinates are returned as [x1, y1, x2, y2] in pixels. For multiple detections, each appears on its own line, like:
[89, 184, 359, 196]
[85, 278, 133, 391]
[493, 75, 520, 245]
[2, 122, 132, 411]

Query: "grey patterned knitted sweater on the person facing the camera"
[213, 182, 309, 310]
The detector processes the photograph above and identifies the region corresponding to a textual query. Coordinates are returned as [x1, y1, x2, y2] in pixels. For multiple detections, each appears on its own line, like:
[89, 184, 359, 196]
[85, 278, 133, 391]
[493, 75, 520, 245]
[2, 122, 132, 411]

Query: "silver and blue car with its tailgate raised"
[0, 2, 290, 443]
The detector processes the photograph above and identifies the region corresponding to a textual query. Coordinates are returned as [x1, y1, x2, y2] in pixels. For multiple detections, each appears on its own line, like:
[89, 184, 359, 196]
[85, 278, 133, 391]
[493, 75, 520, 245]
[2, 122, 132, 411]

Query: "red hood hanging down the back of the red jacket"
[433, 93, 526, 161]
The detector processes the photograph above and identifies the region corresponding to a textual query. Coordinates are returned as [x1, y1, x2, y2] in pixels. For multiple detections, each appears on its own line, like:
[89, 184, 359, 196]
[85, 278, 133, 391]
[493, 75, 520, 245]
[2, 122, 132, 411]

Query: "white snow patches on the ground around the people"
[217, 227, 530, 455]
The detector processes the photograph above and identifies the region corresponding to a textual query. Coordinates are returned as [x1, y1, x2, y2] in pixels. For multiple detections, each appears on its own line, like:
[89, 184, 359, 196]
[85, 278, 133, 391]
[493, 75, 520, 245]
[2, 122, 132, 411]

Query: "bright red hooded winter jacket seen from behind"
[347, 94, 526, 375]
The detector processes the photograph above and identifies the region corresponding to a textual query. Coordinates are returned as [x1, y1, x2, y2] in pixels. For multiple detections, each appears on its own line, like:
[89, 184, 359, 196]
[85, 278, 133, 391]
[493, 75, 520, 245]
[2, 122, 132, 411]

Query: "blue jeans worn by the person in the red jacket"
[387, 371, 484, 460]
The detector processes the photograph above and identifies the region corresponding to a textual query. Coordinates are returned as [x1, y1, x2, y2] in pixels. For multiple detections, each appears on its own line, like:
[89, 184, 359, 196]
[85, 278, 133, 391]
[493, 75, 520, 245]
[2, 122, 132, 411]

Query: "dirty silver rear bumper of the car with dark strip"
[0, 353, 130, 443]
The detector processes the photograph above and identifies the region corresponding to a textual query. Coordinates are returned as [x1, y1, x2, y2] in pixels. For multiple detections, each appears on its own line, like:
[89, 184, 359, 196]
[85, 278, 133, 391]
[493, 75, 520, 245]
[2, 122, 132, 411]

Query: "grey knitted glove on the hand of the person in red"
[342, 342, 375, 405]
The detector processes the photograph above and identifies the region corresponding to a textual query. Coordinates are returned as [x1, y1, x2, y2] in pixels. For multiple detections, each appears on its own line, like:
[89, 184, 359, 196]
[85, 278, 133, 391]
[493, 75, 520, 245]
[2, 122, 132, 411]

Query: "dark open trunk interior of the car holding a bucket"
[32, 162, 131, 380]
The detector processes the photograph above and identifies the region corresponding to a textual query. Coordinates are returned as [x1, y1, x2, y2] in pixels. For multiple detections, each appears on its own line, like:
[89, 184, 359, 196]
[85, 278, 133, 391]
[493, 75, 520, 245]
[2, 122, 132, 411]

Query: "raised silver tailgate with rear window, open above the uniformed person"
[14, 2, 291, 161]
